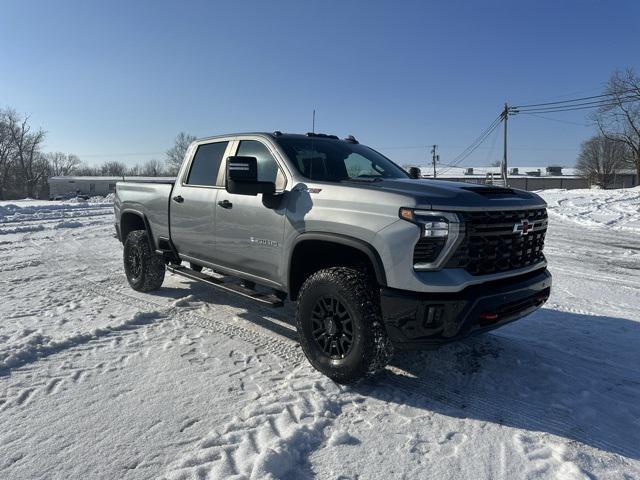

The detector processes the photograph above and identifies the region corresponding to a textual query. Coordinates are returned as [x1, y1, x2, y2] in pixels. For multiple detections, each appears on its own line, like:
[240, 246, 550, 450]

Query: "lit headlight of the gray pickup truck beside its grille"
[398, 207, 462, 270]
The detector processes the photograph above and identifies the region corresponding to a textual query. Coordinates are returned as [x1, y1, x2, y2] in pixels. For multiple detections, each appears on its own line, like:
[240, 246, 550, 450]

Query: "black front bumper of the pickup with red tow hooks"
[380, 268, 551, 348]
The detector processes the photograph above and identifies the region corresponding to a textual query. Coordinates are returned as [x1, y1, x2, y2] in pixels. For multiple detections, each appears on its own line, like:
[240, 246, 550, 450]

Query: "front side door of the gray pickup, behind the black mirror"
[215, 138, 286, 284]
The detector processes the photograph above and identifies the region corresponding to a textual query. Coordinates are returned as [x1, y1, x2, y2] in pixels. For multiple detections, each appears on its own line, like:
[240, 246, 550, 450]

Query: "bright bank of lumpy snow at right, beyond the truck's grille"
[537, 187, 640, 231]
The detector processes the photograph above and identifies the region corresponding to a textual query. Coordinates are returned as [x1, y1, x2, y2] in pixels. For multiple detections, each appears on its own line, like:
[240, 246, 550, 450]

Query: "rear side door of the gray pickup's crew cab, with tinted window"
[169, 140, 231, 262]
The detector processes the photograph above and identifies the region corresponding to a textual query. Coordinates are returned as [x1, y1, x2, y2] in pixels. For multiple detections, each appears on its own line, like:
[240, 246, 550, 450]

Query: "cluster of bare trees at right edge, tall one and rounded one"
[576, 68, 640, 188]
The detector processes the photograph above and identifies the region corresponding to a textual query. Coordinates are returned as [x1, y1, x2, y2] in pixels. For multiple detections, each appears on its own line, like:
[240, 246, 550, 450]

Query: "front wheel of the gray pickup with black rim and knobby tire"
[296, 267, 393, 384]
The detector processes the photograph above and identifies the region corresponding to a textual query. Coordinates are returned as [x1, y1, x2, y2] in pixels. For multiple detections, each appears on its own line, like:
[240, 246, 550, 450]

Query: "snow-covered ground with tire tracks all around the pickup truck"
[0, 188, 640, 480]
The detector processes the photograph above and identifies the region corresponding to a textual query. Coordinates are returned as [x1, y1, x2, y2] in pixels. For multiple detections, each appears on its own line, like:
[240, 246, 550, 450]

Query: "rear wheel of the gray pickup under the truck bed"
[123, 230, 165, 292]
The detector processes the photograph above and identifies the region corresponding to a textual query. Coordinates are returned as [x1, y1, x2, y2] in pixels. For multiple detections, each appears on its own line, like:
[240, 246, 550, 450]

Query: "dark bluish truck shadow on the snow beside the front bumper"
[356, 309, 640, 460]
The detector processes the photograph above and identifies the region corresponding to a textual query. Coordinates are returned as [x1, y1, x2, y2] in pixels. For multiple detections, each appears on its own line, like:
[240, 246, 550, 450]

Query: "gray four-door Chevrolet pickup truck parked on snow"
[115, 132, 551, 383]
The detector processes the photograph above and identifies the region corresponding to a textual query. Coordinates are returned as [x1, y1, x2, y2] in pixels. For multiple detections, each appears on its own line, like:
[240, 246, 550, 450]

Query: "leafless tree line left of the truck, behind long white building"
[0, 108, 195, 200]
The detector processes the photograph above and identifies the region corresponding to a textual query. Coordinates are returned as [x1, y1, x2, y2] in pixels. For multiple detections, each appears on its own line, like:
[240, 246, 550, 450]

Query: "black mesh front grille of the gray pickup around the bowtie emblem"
[446, 208, 547, 275]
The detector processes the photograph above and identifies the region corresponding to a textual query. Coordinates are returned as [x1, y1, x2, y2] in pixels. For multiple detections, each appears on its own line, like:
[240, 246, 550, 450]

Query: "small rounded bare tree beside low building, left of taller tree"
[576, 135, 630, 188]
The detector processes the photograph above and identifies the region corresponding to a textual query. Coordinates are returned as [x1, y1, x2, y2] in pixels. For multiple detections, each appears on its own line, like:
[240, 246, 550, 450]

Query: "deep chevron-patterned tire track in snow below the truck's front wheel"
[162, 366, 348, 480]
